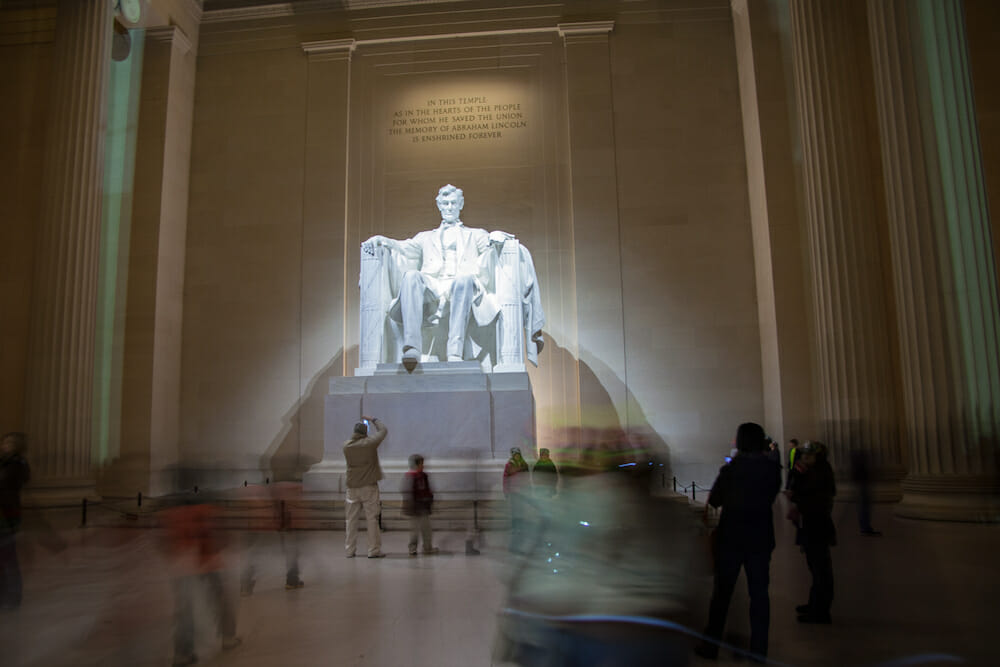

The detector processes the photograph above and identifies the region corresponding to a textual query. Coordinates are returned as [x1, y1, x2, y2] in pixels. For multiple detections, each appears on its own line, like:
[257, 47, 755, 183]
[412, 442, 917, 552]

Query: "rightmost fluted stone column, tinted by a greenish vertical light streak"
[868, 0, 1000, 520]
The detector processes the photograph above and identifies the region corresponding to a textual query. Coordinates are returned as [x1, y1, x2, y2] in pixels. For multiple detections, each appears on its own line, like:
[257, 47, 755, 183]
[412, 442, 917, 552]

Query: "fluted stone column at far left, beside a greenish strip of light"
[25, 0, 112, 500]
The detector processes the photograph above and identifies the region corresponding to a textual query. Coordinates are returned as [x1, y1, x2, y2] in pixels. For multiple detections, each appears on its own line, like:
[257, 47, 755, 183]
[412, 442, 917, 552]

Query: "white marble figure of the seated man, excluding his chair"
[361, 185, 545, 370]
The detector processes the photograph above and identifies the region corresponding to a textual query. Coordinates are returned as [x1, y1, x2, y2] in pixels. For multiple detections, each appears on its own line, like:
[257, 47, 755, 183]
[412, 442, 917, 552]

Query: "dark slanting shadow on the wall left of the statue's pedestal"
[260, 346, 346, 482]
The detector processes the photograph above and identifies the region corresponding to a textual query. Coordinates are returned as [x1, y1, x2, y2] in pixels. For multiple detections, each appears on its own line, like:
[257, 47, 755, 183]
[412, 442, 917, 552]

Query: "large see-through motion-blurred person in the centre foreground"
[493, 432, 699, 667]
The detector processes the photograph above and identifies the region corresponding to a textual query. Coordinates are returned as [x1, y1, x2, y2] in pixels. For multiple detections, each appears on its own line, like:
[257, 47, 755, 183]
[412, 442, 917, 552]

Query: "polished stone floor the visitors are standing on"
[0, 504, 1000, 667]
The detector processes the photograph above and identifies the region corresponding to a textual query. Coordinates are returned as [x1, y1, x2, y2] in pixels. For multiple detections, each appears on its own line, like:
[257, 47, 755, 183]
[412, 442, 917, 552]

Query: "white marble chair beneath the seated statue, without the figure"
[355, 237, 545, 376]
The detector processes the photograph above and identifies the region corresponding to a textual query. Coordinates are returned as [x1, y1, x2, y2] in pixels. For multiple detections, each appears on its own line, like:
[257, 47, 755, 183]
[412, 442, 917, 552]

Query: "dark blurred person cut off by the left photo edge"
[0, 432, 31, 609]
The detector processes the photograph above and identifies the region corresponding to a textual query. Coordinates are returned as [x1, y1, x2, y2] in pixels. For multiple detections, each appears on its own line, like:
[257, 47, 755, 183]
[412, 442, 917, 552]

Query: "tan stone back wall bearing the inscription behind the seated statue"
[172, 2, 764, 490]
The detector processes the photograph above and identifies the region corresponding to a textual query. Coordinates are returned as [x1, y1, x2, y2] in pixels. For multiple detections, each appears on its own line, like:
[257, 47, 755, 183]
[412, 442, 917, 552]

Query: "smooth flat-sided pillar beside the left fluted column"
[116, 25, 197, 495]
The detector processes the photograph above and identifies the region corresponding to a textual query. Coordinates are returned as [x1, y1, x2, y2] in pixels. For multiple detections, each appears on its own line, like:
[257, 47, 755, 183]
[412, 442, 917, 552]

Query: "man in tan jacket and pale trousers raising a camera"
[344, 416, 388, 558]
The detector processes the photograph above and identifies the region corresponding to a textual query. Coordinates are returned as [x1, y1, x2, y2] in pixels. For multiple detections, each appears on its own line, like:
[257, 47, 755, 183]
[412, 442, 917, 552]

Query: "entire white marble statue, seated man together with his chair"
[360, 185, 545, 371]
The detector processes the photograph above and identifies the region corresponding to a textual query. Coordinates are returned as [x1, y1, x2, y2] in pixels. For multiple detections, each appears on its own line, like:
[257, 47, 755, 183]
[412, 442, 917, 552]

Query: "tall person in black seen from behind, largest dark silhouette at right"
[695, 422, 781, 661]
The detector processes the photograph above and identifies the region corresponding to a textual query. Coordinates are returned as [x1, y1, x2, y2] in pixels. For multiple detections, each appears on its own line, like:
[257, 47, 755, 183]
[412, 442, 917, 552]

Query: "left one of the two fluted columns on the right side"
[790, 0, 901, 490]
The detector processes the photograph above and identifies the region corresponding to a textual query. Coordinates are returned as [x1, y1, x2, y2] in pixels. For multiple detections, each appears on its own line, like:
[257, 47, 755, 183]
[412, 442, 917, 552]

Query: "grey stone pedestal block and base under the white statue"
[302, 361, 535, 500]
